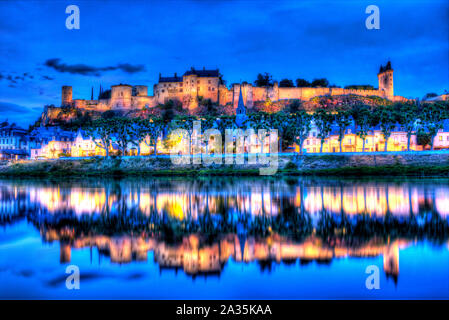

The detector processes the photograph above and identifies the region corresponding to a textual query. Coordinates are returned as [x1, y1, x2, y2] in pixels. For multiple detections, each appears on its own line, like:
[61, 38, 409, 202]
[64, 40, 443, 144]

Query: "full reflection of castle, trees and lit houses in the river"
[0, 178, 449, 279]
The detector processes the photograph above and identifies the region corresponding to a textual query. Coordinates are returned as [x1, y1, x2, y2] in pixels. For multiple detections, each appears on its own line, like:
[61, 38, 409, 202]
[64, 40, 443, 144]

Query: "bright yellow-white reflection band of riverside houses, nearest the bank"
[0, 180, 449, 220]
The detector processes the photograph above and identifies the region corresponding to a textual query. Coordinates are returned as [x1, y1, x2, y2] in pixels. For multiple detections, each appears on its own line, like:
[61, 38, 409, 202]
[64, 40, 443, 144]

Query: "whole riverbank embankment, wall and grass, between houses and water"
[0, 151, 449, 177]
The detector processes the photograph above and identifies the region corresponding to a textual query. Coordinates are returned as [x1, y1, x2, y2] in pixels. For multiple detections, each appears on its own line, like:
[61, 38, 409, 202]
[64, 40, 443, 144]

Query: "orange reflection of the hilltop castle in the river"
[52, 232, 407, 279]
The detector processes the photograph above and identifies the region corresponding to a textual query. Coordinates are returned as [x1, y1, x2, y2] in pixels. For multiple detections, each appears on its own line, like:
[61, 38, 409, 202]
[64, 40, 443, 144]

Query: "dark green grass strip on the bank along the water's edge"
[0, 155, 449, 177]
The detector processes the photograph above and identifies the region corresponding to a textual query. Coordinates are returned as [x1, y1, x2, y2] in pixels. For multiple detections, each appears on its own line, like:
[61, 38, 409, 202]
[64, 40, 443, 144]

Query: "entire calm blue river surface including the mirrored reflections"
[0, 177, 449, 299]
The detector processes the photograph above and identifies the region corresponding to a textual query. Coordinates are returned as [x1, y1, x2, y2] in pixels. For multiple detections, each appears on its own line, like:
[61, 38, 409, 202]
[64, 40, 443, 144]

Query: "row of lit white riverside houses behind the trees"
[0, 120, 449, 160]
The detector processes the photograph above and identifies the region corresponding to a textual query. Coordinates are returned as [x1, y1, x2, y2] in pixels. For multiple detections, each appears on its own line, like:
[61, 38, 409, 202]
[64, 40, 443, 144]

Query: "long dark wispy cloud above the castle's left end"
[45, 58, 145, 77]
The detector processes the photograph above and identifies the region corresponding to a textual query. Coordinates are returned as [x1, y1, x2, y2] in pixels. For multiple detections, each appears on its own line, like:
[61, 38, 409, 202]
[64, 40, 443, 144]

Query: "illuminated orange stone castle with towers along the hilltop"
[57, 62, 404, 111]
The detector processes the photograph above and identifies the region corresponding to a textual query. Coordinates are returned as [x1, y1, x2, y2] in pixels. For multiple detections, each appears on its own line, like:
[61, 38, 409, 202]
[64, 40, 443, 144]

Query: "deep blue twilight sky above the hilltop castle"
[0, 0, 449, 126]
